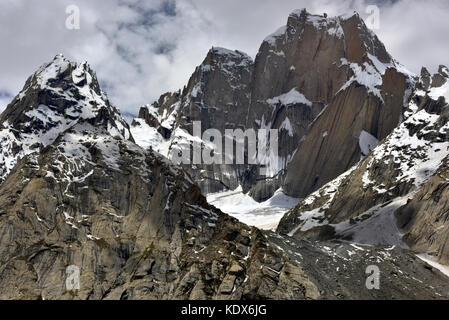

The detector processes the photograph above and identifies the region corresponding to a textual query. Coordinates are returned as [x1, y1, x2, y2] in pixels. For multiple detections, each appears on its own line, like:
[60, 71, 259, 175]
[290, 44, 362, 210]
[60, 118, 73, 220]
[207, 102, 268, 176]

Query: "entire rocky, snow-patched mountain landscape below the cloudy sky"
[0, 10, 449, 300]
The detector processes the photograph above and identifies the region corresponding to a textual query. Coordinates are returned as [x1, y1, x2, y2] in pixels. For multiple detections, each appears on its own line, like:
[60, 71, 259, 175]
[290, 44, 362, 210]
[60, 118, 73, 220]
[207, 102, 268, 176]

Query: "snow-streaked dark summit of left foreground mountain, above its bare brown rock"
[0, 54, 132, 182]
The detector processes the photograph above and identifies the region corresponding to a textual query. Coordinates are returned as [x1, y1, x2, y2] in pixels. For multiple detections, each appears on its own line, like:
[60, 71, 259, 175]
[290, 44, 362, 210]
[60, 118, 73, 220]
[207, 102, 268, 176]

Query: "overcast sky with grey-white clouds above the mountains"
[0, 0, 449, 114]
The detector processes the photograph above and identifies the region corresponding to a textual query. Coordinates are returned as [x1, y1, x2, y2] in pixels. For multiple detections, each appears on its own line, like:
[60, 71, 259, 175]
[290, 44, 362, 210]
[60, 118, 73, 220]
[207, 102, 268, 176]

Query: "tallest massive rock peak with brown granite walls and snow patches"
[245, 10, 411, 199]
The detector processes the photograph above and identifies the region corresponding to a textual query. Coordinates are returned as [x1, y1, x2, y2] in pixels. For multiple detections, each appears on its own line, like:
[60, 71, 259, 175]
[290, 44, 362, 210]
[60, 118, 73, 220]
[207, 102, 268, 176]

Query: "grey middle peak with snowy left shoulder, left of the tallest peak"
[131, 48, 253, 194]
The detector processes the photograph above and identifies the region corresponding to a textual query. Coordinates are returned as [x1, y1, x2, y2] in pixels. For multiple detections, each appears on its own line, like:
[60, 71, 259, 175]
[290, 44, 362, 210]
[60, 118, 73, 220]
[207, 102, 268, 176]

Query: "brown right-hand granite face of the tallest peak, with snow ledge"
[283, 11, 410, 198]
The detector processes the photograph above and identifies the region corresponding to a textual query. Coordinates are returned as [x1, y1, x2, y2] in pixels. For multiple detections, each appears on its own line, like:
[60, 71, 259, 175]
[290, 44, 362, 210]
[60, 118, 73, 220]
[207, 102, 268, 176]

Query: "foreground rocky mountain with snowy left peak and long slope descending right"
[0, 56, 449, 299]
